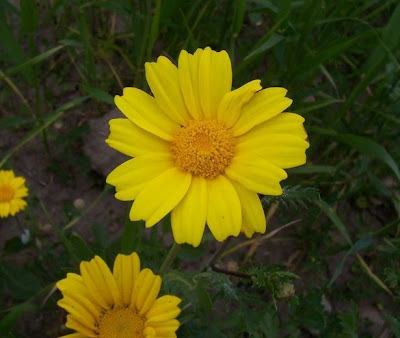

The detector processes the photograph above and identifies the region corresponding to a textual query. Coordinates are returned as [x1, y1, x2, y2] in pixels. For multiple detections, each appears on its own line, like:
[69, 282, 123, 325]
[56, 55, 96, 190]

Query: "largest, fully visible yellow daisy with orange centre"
[106, 47, 309, 246]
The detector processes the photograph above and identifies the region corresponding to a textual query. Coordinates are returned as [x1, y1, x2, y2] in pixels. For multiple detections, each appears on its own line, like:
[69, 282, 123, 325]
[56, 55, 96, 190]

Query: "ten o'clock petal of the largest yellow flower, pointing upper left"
[115, 88, 180, 141]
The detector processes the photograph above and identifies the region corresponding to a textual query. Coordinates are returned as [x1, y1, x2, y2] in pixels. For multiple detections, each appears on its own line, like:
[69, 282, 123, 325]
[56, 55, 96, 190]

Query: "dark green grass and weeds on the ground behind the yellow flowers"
[0, 0, 400, 337]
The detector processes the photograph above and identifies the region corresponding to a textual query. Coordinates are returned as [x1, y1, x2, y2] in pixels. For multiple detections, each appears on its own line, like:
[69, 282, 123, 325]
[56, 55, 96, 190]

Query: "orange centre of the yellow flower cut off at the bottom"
[98, 307, 145, 338]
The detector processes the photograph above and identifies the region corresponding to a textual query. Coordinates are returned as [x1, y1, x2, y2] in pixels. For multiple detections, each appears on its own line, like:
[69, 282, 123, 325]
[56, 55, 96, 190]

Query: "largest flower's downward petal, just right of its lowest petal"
[207, 175, 242, 242]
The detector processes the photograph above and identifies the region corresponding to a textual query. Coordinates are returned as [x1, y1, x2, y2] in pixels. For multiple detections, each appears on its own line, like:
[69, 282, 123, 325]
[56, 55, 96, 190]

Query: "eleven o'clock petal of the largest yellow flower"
[145, 56, 189, 126]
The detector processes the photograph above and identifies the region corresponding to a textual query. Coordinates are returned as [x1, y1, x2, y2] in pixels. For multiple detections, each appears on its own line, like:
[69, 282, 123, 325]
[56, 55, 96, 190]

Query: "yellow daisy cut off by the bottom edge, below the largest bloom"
[57, 253, 181, 338]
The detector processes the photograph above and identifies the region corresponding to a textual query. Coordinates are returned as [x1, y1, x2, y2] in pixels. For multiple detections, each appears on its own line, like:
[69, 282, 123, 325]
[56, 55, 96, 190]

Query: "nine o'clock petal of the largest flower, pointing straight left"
[106, 119, 170, 157]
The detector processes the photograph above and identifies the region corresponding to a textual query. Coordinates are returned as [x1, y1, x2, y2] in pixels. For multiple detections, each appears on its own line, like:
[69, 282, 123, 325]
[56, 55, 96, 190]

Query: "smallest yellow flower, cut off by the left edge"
[0, 170, 28, 218]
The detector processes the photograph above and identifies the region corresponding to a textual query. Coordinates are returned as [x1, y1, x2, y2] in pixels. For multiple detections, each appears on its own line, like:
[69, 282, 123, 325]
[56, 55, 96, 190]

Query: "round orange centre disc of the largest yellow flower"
[171, 120, 235, 179]
